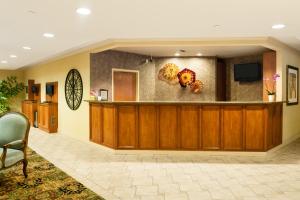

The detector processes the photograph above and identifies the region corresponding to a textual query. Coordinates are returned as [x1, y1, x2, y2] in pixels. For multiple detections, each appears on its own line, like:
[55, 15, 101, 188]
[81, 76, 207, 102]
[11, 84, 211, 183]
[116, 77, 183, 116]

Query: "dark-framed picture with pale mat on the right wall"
[286, 65, 299, 105]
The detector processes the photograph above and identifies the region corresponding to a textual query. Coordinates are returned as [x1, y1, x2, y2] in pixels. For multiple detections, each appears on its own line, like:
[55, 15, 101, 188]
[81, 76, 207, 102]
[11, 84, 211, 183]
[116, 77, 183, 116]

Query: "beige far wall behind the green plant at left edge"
[0, 70, 25, 112]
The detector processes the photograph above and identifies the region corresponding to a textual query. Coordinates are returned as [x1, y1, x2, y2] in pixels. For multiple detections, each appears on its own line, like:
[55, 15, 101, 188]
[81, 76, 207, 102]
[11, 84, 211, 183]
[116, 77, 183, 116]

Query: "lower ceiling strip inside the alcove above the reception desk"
[114, 46, 268, 58]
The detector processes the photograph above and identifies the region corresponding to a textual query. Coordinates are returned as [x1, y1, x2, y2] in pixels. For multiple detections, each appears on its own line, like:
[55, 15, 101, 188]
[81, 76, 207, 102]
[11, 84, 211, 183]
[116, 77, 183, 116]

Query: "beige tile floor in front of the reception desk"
[29, 129, 300, 200]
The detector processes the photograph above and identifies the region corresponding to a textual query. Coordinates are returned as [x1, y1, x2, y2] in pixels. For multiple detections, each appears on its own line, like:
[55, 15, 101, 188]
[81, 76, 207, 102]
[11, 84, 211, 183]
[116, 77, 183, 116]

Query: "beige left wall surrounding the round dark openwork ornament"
[24, 52, 90, 140]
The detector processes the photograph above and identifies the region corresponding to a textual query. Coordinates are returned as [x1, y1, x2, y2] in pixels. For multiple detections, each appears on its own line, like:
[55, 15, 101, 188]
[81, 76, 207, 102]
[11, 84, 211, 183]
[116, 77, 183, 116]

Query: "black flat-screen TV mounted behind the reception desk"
[234, 63, 262, 82]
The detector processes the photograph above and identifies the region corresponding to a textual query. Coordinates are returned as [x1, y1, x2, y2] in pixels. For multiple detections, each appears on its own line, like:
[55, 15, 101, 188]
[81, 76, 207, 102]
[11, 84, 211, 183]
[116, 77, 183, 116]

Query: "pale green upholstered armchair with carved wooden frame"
[0, 112, 30, 178]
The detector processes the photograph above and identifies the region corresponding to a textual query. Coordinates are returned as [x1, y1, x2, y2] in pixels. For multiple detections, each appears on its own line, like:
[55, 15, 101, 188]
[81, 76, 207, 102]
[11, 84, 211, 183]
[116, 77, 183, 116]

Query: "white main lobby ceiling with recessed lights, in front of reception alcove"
[0, 0, 300, 69]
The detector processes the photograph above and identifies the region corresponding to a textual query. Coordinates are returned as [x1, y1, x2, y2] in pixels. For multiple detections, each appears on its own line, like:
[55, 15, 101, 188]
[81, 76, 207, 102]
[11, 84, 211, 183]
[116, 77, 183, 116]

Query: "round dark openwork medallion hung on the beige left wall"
[65, 69, 83, 110]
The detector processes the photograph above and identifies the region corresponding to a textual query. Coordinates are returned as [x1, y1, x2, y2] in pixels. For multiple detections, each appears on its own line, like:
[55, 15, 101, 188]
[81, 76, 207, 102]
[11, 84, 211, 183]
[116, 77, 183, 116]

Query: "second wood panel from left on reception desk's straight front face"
[139, 106, 158, 149]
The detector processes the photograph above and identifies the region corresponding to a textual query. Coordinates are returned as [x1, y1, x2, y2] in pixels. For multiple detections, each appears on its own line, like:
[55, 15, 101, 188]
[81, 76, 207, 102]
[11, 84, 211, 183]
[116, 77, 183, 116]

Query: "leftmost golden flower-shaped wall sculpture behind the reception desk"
[158, 63, 179, 85]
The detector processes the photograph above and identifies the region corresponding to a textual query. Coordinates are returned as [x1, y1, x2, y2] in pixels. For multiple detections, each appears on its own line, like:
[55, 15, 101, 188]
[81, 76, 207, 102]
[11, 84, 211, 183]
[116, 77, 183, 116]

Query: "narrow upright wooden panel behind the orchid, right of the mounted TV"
[262, 51, 276, 101]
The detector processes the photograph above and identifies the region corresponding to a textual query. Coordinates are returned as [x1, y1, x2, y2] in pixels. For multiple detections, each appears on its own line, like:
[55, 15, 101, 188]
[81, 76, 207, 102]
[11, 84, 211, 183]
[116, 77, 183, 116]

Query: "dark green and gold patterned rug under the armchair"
[0, 149, 104, 200]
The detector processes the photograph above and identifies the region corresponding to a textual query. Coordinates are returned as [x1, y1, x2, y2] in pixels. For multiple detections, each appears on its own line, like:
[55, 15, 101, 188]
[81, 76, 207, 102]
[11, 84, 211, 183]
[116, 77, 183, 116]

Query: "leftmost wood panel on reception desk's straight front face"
[118, 106, 137, 148]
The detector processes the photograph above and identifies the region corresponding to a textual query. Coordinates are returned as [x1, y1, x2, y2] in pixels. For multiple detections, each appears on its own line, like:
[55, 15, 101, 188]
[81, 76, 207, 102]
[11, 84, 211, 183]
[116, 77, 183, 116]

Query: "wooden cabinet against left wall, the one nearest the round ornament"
[38, 103, 58, 133]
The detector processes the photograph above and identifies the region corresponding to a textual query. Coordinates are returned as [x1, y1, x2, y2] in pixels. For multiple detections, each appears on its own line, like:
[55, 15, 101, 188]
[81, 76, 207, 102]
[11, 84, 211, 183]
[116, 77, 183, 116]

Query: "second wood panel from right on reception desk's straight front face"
[222, 106, 243, 150]
